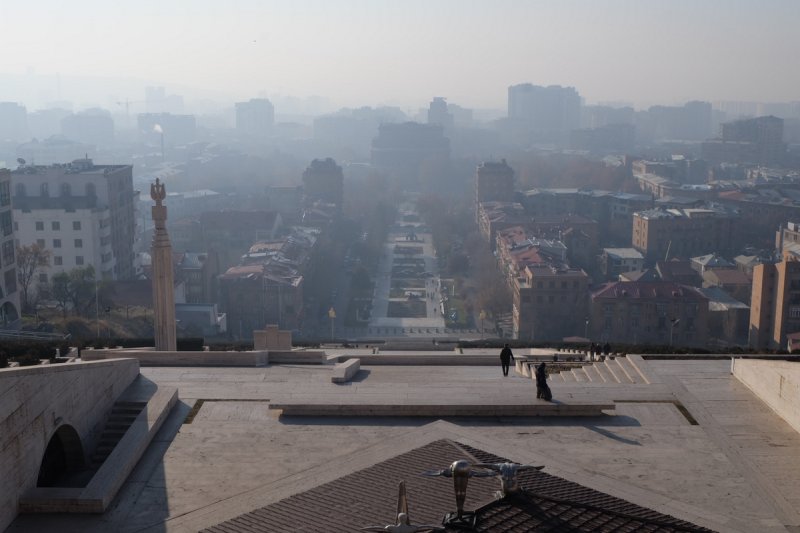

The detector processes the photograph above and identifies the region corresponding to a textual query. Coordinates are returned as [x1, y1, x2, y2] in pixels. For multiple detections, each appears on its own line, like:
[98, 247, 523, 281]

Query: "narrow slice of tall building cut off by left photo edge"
[0, 169, 19, 328]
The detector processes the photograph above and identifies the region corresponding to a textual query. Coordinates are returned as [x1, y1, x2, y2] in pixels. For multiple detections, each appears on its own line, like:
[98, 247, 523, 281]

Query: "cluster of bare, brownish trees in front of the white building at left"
[17, 244, 102, 317]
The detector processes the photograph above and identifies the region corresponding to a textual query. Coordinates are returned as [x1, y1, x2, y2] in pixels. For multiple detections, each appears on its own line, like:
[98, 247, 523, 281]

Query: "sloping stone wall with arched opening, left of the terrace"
[0, 359, 139, 531]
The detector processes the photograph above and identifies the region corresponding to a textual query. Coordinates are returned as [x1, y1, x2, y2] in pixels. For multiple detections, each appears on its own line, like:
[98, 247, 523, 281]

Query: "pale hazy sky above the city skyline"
[0, 0, 800, 108]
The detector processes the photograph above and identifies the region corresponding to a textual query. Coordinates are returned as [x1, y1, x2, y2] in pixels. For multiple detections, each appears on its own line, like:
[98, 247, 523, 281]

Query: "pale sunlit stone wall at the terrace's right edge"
[732, 359, 800, 432]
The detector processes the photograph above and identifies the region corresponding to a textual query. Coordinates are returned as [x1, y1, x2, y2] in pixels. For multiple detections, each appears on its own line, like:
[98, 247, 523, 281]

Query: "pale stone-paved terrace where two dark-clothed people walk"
[9, 360, 800, 533]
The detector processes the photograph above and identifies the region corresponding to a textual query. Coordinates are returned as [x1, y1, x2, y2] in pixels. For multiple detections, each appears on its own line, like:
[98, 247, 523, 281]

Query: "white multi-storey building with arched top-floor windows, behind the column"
[11, 159, 135, 281]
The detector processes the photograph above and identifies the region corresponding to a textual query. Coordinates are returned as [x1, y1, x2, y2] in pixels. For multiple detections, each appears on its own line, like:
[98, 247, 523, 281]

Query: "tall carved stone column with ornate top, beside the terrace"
[150, 178, 176, 352]
